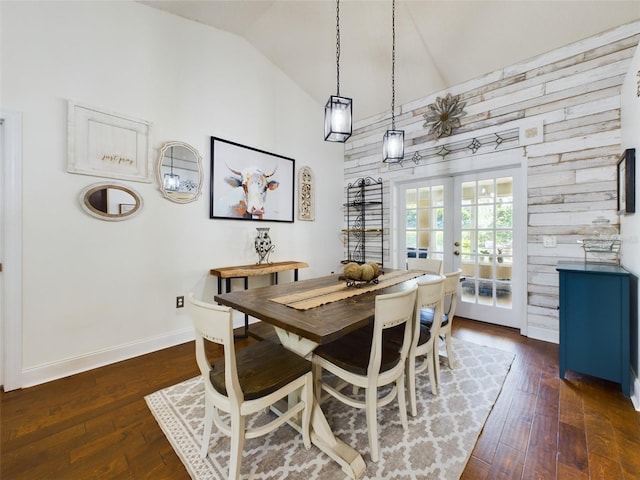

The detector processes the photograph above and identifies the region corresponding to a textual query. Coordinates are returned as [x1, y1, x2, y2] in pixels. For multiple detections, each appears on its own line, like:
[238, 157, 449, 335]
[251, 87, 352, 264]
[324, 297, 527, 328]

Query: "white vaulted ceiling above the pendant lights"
[140, 0, 640, 119]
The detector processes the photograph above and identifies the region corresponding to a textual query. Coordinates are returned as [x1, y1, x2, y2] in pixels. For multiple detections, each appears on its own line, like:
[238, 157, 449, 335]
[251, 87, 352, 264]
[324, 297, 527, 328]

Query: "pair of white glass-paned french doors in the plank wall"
[398, 169, 526, 327]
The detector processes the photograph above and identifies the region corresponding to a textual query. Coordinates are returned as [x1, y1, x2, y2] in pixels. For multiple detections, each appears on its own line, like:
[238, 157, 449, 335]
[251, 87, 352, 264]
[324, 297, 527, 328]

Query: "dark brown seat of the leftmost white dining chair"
[210, 341, 311, 400]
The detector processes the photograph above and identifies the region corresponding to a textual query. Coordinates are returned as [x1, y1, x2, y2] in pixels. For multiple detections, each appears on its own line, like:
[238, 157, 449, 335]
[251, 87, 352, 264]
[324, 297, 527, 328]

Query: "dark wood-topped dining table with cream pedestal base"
[214, 270, 432, 479]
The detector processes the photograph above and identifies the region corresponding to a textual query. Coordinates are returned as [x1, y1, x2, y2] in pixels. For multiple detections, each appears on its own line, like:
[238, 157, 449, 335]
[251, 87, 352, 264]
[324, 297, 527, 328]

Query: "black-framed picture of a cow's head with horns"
[209, 137, 295, 222]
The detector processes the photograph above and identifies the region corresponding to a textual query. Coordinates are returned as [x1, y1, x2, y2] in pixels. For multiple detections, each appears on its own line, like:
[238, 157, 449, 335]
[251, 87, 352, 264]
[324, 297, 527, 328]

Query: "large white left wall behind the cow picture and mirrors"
[0, 1, 343, 385]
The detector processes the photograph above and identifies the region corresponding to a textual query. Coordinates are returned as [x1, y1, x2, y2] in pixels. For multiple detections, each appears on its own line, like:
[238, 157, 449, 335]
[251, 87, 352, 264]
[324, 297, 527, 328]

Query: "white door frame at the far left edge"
[0, 109, 22, 391]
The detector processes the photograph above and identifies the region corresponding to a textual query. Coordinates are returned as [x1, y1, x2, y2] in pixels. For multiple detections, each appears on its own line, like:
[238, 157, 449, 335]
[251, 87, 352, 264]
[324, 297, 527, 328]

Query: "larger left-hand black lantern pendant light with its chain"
[324, 0, 353, 143]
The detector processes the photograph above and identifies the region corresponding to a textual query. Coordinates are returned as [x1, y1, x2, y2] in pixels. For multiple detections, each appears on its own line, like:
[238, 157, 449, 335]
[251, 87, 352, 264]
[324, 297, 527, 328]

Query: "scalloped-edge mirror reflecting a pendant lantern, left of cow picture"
[158, 142, 203, 203]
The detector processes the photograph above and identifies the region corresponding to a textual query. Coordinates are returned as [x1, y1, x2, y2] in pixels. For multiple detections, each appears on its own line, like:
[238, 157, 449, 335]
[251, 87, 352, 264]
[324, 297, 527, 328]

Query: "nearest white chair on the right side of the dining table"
[313, 286, 417, 462]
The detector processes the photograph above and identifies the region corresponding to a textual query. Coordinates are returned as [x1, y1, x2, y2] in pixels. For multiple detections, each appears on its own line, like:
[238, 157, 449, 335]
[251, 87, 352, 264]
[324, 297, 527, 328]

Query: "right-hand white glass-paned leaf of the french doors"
[453, 170, 526, 327]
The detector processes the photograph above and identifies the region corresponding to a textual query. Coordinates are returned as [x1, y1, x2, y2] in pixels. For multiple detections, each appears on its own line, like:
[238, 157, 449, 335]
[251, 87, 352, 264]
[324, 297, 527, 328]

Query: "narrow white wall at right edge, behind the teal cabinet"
[620, 43, 640, 410]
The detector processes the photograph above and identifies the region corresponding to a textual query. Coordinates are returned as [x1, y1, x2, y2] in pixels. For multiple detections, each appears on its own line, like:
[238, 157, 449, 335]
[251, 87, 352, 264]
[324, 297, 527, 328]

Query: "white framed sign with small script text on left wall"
[67, 100, 152, 183]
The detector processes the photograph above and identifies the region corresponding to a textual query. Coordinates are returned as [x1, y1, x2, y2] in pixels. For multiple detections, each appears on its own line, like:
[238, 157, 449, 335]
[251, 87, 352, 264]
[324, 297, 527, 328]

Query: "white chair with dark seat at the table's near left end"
[188, 293, 313, 480]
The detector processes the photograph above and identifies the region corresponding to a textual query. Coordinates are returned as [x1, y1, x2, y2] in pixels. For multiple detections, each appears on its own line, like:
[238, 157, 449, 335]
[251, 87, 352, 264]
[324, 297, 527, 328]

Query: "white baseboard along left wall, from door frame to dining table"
[22, 327, 194, 388]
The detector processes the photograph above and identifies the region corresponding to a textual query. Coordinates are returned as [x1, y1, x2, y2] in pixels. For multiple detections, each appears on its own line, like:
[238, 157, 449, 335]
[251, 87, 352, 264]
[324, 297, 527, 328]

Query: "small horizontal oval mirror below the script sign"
[80, 183, 142, 221]
